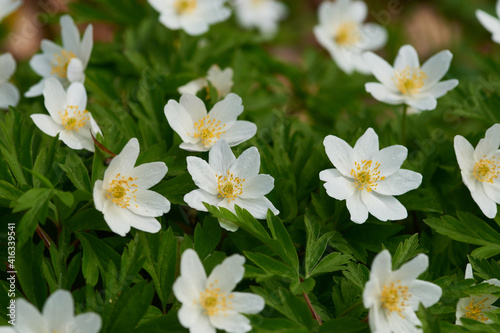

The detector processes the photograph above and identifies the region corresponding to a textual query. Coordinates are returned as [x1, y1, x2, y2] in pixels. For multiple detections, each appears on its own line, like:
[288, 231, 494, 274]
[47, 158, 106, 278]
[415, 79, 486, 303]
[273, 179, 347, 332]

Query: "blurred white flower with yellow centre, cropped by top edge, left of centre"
[148, 0, 231, 36]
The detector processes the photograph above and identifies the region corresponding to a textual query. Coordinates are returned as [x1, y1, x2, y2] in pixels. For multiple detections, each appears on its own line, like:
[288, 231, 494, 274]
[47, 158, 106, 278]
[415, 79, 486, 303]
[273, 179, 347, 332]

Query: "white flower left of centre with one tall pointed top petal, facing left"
[94, 138, 170, 237]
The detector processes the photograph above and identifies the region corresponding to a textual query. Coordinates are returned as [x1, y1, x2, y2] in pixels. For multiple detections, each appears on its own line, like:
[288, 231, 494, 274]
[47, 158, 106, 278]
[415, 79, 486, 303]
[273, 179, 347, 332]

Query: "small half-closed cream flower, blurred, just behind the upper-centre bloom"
[177, 65, 234, 98]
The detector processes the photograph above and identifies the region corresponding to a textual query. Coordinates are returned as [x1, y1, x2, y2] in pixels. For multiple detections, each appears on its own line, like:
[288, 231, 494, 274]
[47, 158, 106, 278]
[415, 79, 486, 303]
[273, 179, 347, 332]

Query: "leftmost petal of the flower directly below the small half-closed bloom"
[164, 99, 200, 143]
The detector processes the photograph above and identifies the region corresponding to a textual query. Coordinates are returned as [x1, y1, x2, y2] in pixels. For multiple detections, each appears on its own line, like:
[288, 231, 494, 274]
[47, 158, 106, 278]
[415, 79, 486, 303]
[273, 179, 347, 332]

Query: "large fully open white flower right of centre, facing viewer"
[319, 128, 422, 223]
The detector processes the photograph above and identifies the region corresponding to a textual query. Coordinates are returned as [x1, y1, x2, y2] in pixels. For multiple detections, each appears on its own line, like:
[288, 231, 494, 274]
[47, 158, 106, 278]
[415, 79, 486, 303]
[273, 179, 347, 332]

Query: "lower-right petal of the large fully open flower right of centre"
[361, 190, 408, 221]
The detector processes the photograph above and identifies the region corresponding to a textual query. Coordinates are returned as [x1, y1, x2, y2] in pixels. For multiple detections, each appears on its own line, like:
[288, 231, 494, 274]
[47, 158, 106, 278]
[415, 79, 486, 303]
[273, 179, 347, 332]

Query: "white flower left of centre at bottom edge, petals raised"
[173, 249, 265, 333]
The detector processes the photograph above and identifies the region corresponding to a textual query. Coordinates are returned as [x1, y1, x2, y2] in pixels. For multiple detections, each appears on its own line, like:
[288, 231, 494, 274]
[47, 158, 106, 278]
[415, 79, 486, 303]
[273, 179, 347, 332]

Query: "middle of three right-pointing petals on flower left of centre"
[128, 190, 170, 217]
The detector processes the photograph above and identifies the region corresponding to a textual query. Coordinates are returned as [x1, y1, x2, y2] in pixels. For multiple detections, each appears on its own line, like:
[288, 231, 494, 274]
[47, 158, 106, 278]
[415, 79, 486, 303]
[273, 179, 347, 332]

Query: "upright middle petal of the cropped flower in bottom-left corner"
[42, 289, 75, 332]
